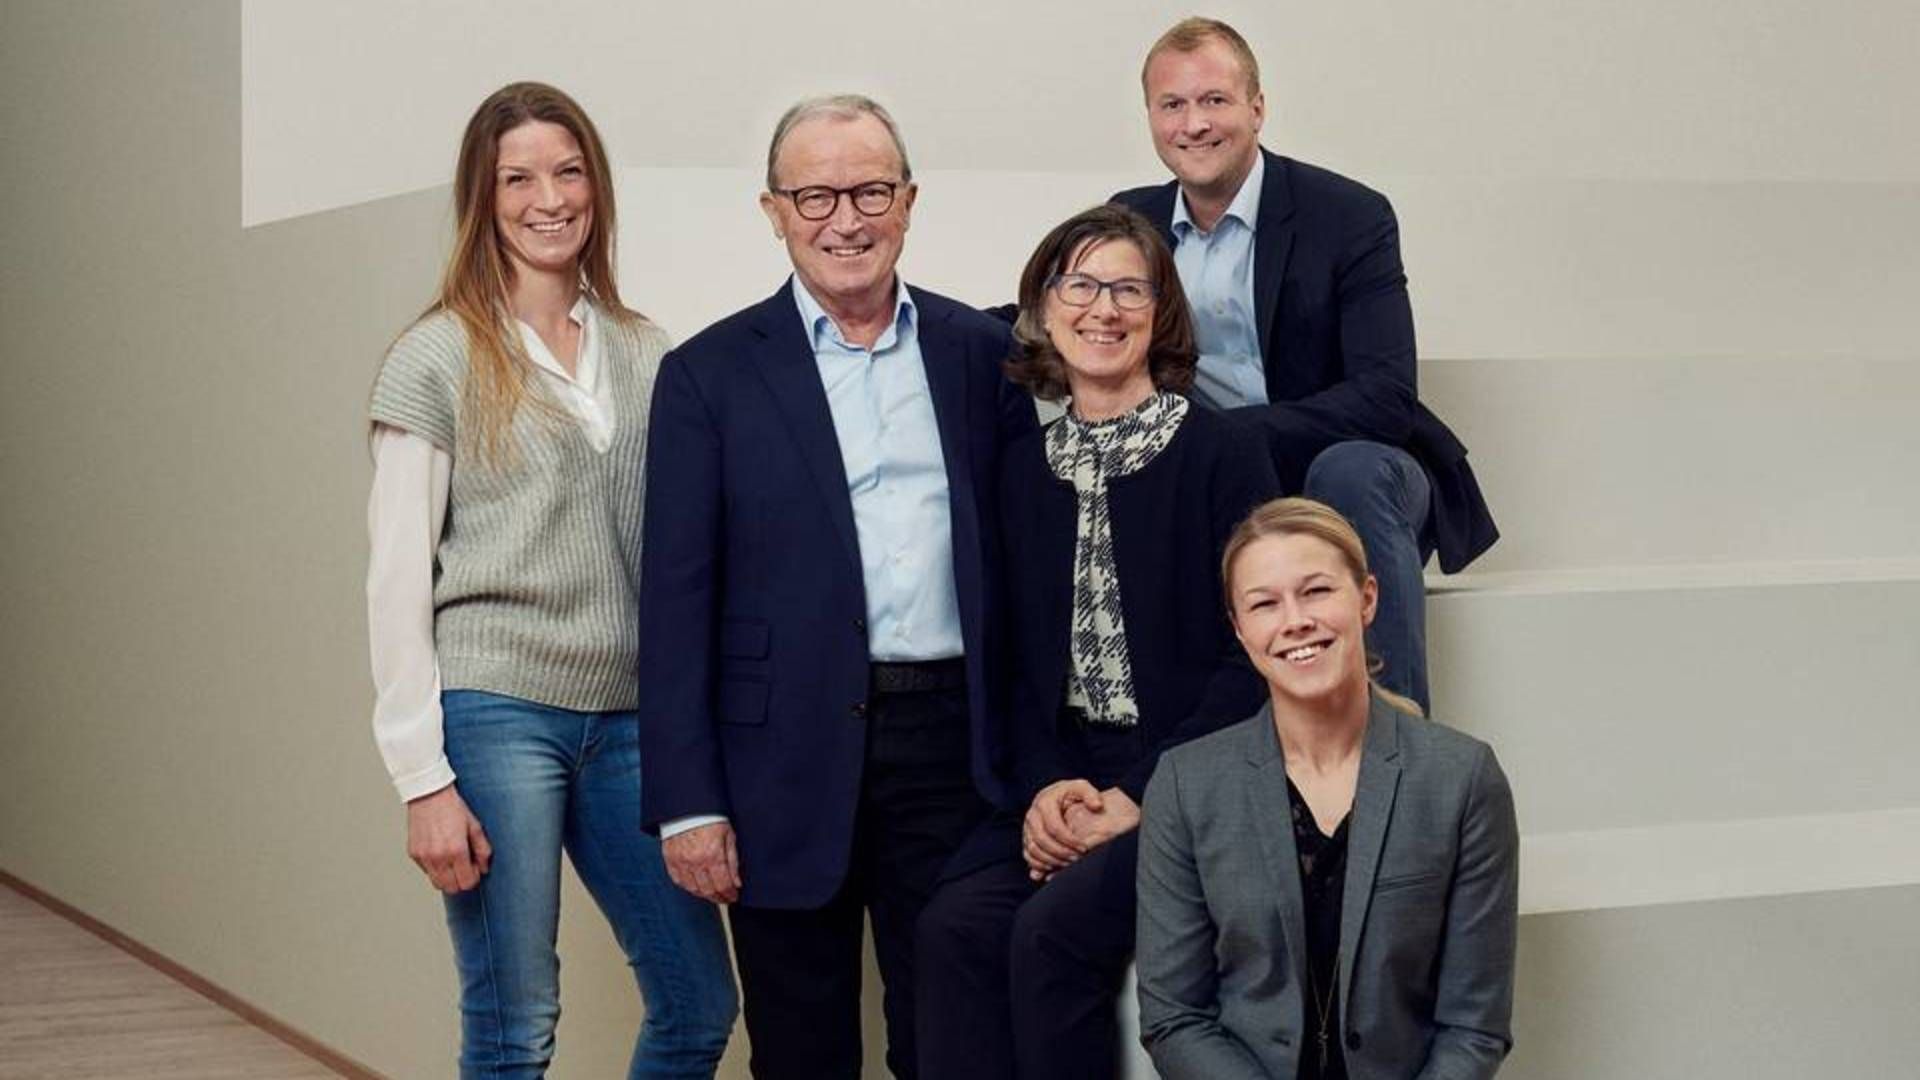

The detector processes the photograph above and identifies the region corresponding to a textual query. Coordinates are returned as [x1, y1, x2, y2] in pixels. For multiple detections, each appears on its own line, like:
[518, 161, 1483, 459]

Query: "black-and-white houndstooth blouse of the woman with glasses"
[1046, 390, 1188, 726]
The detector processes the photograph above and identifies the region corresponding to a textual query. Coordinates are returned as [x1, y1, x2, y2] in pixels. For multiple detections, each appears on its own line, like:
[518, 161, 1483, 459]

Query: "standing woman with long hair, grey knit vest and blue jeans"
[367, 83, 735, 1078]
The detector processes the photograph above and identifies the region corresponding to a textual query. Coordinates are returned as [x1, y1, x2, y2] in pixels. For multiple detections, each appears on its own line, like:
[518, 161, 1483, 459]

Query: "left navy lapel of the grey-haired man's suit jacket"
[753, 279, 860, 580]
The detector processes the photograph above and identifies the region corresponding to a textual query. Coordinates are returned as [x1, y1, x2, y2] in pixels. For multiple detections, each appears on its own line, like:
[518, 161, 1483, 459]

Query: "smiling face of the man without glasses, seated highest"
[1146, 38, 1267, 200]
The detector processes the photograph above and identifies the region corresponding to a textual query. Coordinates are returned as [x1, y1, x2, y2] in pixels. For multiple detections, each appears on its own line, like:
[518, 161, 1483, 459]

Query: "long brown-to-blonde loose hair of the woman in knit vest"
[426, 83, 639, 463]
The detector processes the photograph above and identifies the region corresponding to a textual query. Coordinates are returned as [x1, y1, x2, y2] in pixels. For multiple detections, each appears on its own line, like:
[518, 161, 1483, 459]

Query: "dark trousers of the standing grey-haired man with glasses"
[728, 672, 987, 1080]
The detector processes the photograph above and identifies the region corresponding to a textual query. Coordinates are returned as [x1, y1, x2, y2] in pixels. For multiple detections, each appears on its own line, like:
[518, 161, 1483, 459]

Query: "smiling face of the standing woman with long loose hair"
[493, 119, 593, 275]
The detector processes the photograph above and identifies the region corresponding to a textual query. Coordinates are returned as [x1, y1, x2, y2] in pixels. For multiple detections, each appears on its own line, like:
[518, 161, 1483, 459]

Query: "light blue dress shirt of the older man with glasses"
[793, 275, 966, 661]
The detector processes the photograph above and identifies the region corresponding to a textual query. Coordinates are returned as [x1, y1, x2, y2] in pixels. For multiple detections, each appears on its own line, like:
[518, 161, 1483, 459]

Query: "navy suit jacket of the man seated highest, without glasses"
[1112, 150, 1500, 573]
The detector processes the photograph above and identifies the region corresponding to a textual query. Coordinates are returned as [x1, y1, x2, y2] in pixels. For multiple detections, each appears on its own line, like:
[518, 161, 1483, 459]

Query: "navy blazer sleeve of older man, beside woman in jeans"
[639, 350, 732, 834]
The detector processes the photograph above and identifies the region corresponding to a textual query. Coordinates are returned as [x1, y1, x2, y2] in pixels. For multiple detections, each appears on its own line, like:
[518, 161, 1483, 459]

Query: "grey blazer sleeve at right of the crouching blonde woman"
[1417, 746, 1521, 1080]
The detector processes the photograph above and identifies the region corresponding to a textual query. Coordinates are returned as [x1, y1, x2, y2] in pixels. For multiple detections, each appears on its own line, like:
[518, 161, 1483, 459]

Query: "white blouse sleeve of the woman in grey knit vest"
[367, 423, 453, 799]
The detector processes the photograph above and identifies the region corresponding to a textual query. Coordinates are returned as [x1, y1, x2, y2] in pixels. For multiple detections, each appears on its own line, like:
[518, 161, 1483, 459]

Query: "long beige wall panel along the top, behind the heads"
[242, 0, 1920, 223]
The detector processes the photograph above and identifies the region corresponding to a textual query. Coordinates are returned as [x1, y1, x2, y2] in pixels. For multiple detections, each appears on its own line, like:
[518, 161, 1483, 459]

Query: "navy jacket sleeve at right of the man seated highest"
[1238, 192, 1419, 480]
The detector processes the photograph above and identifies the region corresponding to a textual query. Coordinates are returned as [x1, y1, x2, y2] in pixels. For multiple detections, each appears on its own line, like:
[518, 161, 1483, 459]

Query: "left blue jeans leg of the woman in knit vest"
[442, 690, 578, 1080]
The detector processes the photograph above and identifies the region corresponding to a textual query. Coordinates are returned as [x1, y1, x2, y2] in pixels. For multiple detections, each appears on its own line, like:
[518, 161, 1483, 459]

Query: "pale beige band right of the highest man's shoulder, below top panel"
[1397, 173, 1920, 363]
